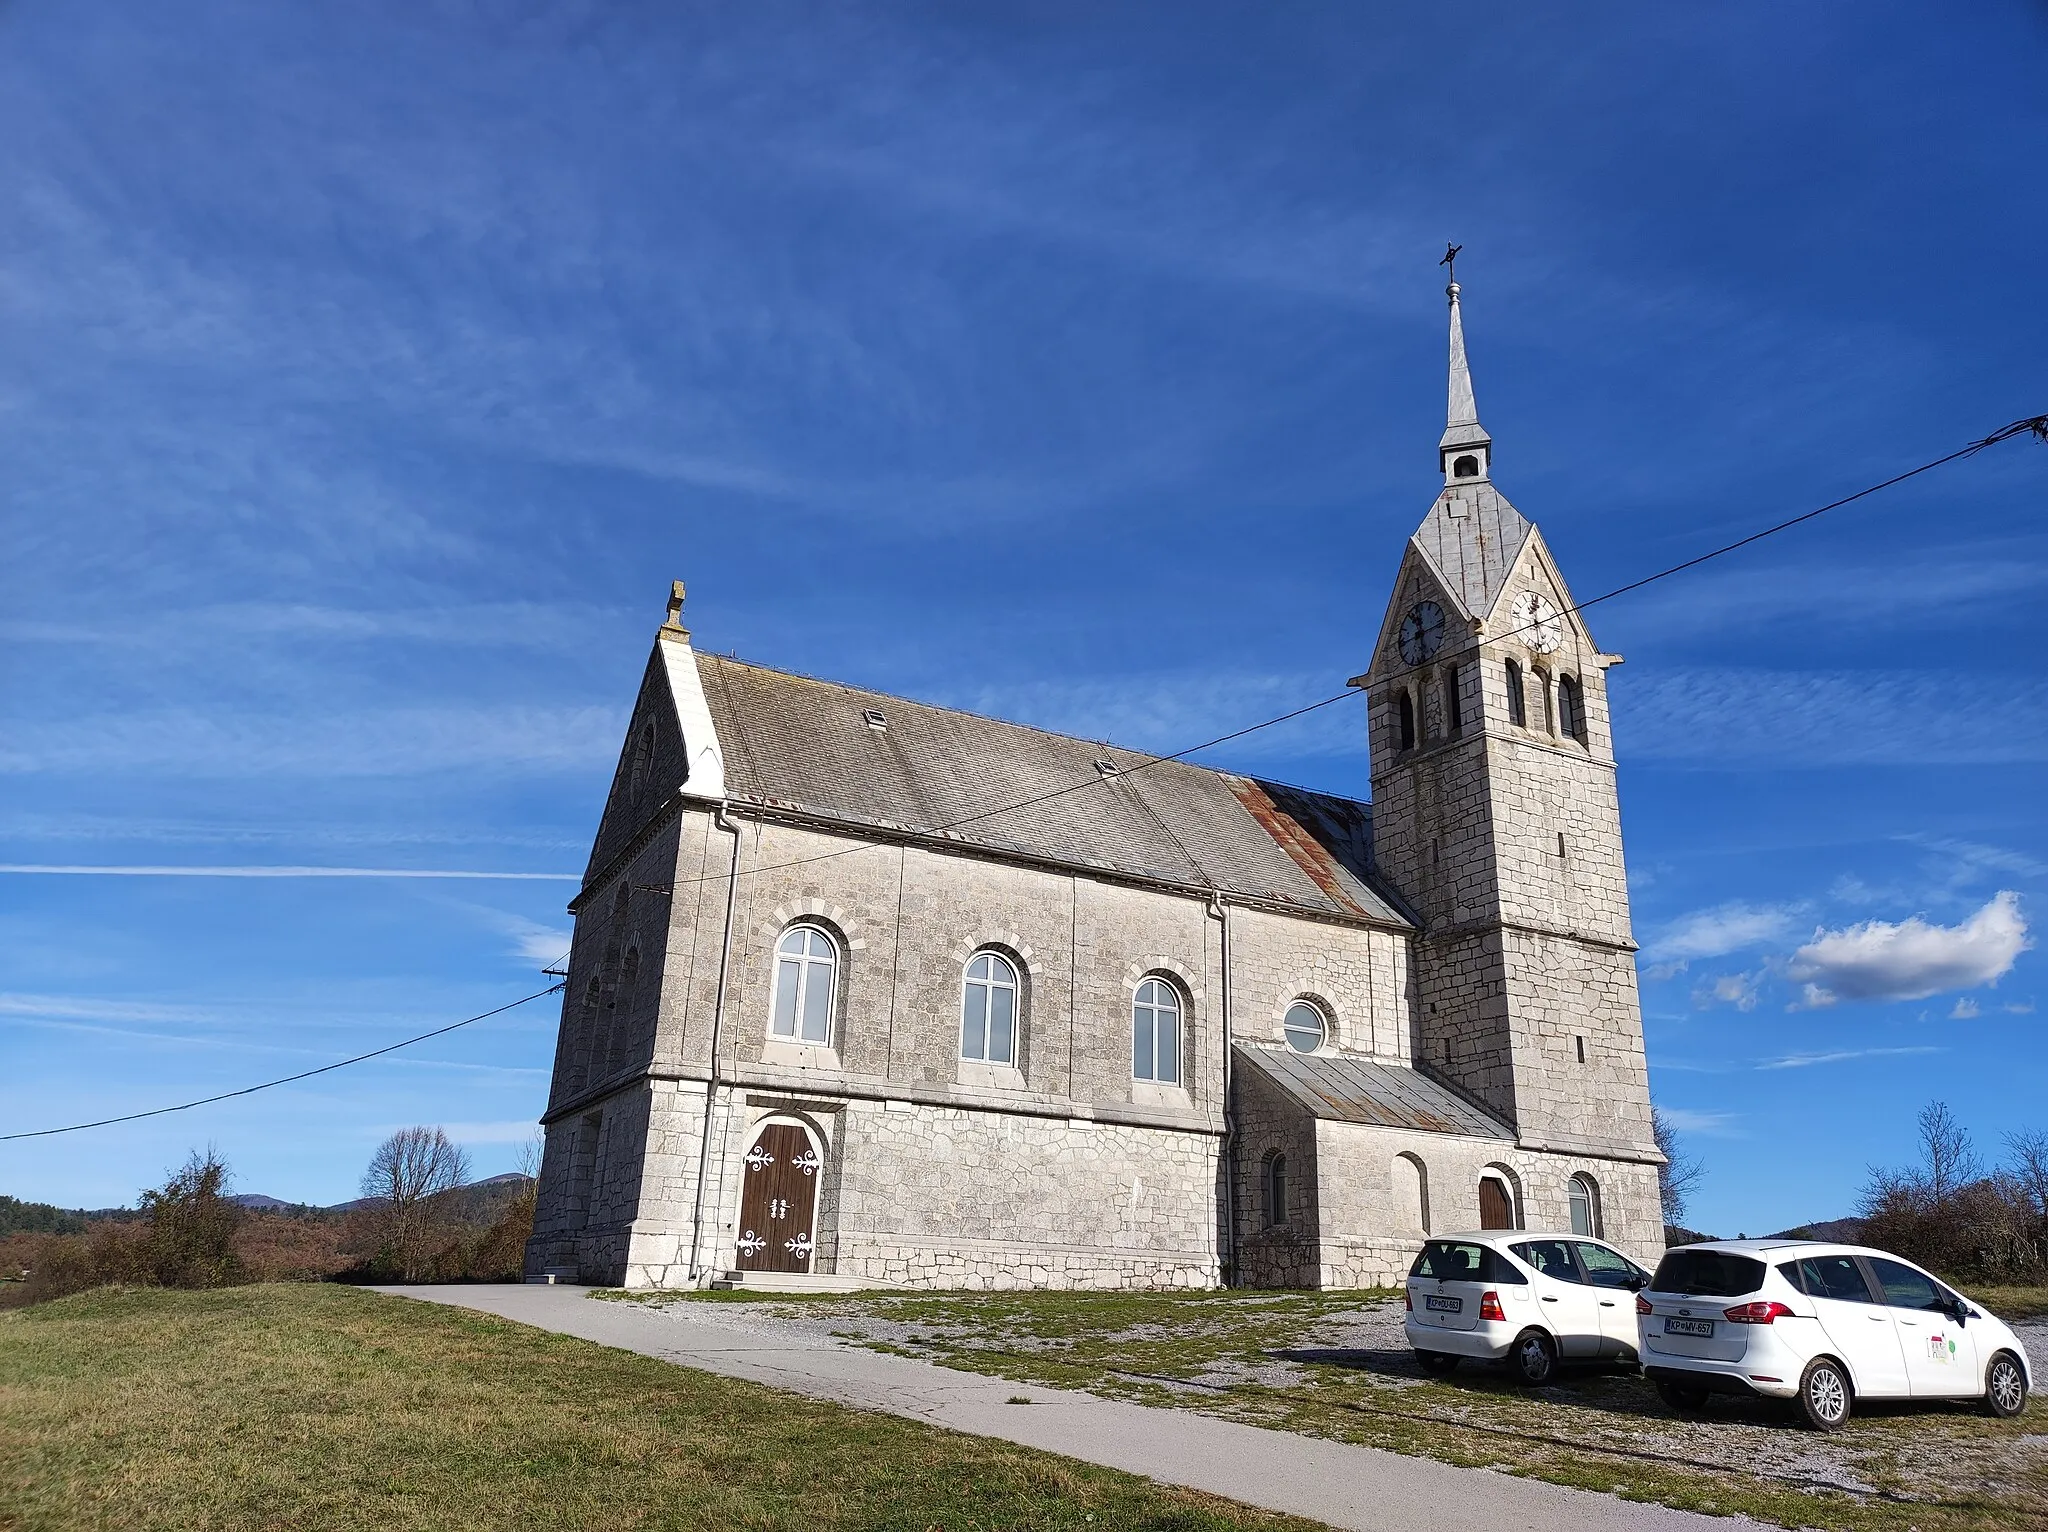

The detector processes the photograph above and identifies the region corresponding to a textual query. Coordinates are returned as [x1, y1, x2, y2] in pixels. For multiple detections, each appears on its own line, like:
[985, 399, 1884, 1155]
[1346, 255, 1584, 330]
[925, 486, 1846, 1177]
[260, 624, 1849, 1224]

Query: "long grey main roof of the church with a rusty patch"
[696, 653, 1407, 926]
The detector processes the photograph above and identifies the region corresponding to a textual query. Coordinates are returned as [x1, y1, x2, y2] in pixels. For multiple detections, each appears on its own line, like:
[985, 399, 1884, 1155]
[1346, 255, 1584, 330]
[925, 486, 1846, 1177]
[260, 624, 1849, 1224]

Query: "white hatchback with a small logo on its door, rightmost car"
[1636, 1239, 2032, 1432]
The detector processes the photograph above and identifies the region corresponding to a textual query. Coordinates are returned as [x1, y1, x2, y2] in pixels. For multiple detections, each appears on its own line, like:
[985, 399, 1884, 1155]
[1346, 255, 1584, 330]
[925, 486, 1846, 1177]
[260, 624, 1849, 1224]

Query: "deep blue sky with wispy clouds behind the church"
[0, 0, 2048, 1233]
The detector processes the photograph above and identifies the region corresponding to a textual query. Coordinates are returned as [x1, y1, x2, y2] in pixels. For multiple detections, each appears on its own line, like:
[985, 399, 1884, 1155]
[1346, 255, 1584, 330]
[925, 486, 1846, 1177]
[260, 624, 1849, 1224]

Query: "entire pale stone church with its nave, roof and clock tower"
[526, 283, 1663, 1288]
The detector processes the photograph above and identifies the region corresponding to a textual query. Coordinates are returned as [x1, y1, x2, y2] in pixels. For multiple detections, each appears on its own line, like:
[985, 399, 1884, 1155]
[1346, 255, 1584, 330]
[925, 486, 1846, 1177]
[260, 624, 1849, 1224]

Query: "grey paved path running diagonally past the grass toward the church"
[377, 1286, 1757, 1532]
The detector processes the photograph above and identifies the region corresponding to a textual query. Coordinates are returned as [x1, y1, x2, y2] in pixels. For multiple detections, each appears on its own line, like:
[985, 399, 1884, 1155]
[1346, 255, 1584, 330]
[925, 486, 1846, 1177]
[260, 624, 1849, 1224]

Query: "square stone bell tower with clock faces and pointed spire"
[1356, 268, 1655, 1161]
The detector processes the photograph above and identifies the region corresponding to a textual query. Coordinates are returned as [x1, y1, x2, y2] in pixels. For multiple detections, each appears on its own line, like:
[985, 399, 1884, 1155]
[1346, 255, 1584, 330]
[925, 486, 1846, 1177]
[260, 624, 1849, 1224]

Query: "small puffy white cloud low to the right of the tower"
[1786, 889, 2032, 1008]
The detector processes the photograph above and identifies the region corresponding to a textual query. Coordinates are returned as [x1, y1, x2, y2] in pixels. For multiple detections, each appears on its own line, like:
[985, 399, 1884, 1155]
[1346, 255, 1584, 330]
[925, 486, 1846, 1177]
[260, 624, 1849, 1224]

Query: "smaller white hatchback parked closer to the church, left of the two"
[1403, 1229, 1649, 1385]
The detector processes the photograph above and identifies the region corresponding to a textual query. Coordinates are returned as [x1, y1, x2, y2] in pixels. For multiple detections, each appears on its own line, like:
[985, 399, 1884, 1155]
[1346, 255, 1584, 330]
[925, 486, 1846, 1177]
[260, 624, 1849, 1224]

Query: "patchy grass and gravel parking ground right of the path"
[606, 1288, 2048, 1532]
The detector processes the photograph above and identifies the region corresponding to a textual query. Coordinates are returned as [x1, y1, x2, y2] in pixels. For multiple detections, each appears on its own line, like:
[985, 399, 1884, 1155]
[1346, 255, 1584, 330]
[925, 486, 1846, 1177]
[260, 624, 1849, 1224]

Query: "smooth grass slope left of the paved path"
[0, 1284, 1309, 1532]
